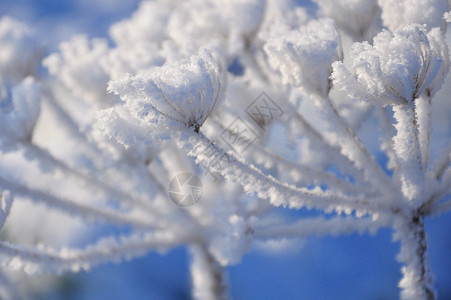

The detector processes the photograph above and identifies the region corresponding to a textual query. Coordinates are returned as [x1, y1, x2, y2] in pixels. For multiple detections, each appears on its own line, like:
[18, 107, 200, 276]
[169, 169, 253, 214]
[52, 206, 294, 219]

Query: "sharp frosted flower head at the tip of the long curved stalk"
[108, 49, 225, 131]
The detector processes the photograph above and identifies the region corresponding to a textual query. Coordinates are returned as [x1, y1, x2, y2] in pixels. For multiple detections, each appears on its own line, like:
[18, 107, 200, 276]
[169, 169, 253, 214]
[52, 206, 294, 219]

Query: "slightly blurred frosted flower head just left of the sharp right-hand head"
[264, 19, 343, 95]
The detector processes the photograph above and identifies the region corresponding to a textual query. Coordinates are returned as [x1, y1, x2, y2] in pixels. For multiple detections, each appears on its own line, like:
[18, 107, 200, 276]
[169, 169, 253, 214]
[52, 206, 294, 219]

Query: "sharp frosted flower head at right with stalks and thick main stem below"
[332, 25, 449, 299]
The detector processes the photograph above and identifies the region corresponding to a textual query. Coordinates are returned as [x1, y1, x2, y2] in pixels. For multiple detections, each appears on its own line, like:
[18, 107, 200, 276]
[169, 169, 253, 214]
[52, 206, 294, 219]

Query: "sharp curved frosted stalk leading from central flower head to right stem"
[178, 127, 392, 213]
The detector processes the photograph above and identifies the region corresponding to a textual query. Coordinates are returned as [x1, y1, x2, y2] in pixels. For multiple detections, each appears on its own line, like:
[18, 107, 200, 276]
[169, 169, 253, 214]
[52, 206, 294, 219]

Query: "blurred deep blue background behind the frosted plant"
[0, 0, 451, 300]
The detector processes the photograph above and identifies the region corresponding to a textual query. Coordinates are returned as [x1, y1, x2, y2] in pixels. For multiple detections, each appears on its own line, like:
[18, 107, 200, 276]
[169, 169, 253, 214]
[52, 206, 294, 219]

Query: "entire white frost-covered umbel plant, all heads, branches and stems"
[0, 0, 451, 299]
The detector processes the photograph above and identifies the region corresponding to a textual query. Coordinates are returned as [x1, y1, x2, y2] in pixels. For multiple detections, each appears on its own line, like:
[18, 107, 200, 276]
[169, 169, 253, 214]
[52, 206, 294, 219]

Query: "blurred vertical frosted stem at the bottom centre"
[190, 244, 229, 300]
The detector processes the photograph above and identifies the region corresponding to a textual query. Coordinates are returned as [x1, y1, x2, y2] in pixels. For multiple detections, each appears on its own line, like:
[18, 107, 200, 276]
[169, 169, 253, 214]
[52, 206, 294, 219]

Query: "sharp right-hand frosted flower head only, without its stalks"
[332, 25, 449, 106]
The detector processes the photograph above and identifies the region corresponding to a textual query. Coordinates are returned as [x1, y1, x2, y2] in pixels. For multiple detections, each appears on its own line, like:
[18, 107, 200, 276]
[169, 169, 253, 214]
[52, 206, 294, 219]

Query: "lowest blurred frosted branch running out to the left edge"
[0, 230, 193, 274]
